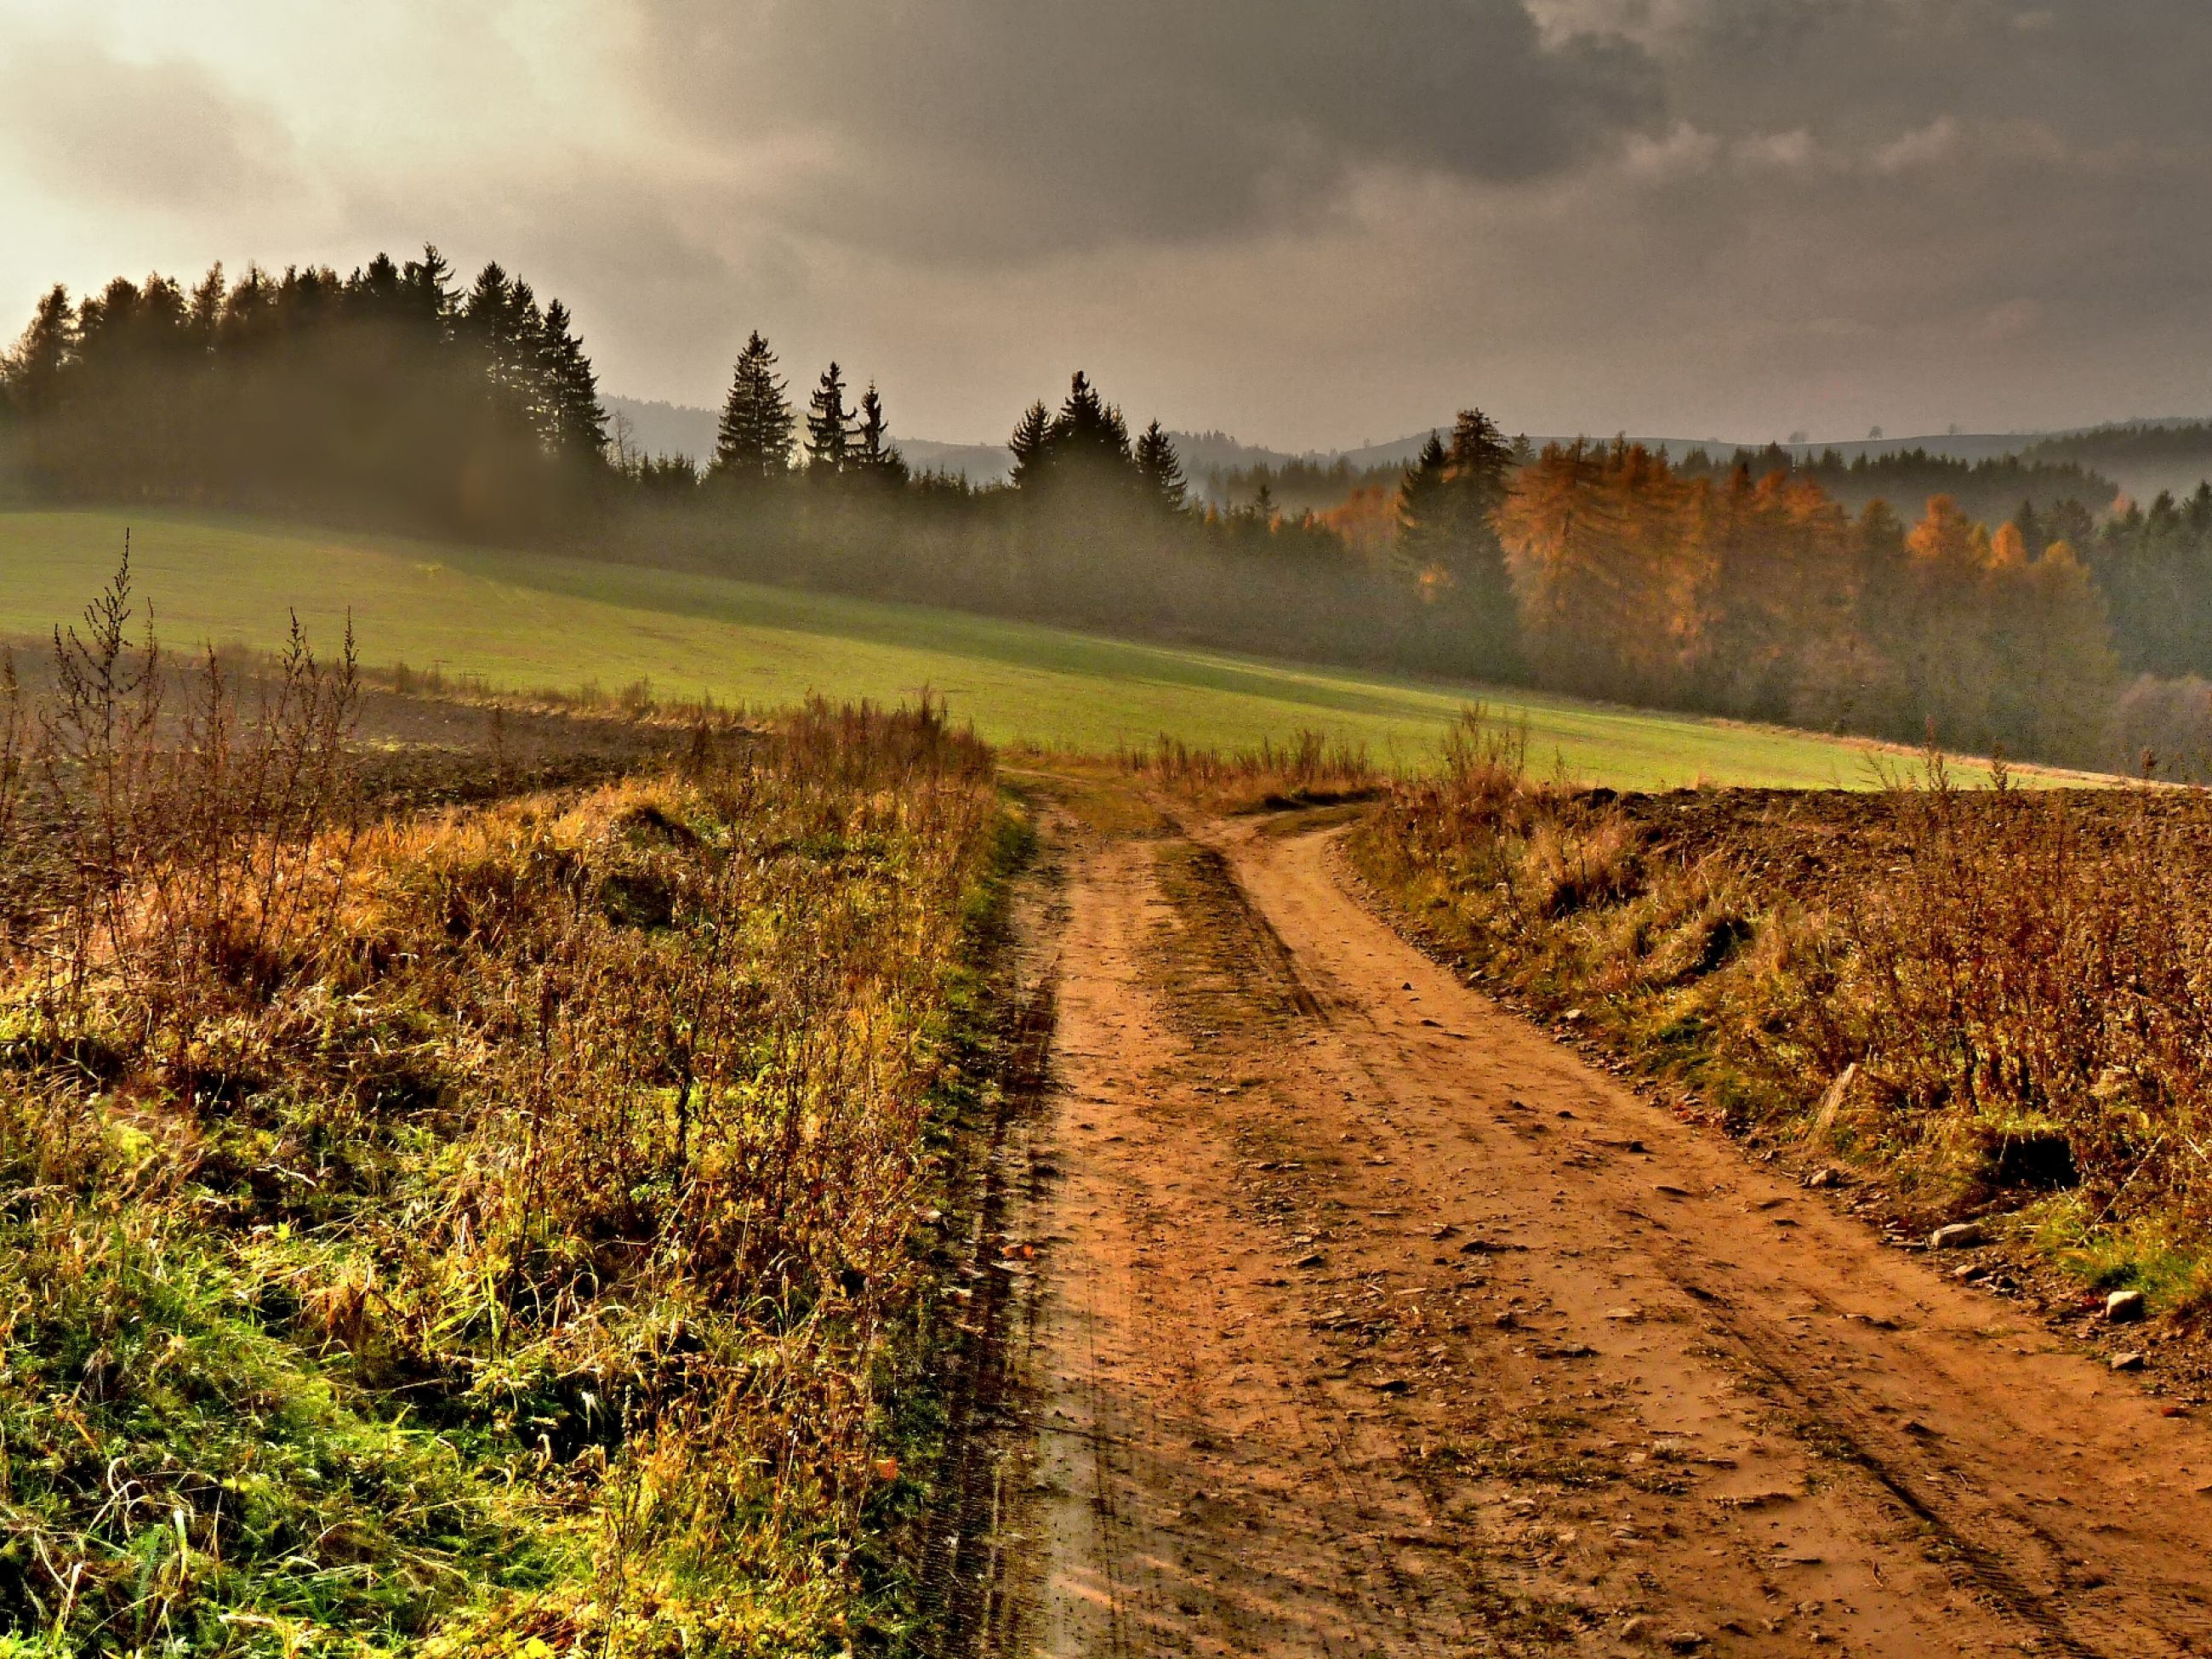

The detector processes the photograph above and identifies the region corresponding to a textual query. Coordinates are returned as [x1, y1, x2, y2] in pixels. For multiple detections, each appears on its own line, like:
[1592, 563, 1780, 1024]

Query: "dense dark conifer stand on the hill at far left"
[0, 248, 606, 533]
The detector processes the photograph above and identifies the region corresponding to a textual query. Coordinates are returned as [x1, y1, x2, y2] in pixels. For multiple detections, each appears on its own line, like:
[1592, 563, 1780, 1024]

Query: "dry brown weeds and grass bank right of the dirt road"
[1354, 716, 2212, 1319]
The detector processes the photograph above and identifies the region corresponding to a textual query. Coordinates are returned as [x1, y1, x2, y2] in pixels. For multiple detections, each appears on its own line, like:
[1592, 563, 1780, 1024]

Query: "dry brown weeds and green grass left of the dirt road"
[0, 566, 1013, 1655]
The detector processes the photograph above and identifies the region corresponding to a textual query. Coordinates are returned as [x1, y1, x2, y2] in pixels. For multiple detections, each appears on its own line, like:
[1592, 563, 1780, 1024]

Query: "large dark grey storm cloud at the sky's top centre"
[639, 0, 1662, 257]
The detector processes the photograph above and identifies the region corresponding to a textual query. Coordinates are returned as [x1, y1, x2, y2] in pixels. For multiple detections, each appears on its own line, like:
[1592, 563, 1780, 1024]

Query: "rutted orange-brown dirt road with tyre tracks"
[964, 801, 2212, 1655]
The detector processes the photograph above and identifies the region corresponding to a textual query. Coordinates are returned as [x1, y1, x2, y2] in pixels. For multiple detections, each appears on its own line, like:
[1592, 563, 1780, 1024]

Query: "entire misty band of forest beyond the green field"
[0, 248, 2212, 766]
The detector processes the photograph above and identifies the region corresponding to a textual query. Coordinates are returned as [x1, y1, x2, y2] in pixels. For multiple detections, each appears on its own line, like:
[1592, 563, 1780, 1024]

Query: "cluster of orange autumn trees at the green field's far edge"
[1496, 442, 2117, 761]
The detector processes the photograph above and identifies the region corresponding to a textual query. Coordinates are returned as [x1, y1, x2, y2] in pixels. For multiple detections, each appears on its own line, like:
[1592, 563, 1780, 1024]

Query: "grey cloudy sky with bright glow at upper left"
[0, 0, 2212, 447]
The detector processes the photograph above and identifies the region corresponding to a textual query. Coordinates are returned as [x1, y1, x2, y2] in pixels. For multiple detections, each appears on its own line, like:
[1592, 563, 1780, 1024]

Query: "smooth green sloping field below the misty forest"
[0, 511, 1991, 788]
